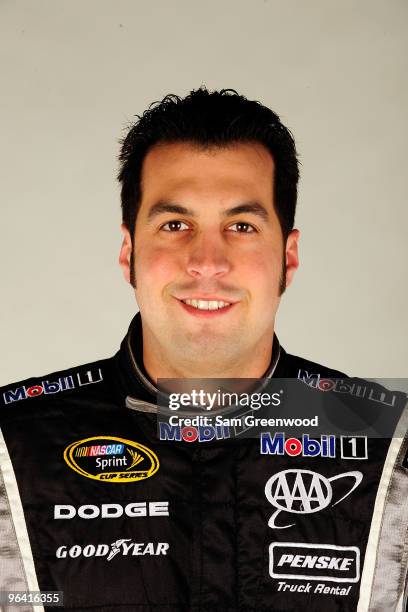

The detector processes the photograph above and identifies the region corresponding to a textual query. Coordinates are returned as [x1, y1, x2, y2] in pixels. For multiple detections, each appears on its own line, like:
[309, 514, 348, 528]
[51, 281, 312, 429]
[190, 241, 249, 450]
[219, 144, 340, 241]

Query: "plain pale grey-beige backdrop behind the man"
[0, 0, 408, 384]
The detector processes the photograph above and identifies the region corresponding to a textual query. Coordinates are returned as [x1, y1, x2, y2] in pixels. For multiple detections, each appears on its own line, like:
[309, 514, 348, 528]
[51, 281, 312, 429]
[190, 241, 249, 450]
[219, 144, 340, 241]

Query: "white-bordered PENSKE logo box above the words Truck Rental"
[269, 542, 360, 583]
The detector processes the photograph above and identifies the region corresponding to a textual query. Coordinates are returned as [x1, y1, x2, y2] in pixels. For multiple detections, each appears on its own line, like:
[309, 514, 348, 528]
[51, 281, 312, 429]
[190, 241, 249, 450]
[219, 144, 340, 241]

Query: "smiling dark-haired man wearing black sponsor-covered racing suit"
[0, 88, 408, 612]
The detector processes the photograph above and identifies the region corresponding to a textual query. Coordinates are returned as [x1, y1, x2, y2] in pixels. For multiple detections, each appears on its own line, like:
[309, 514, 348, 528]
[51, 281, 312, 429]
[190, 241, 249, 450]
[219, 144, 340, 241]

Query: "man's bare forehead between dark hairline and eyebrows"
[141, 142, 274, 205]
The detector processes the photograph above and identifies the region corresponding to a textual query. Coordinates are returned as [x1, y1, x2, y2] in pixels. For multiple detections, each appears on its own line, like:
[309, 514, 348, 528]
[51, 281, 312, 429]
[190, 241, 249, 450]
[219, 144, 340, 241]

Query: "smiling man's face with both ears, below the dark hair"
[120, 143, 298, 375]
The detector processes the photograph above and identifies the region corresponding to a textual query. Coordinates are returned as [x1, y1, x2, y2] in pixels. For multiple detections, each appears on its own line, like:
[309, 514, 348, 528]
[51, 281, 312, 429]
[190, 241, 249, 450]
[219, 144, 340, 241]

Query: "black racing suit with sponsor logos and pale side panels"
[0, 313, 408, 612]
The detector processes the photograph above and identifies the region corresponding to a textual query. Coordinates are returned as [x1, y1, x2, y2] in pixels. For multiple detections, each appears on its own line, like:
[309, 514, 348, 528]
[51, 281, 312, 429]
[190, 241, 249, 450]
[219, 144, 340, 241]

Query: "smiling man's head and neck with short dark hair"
[115, 91, 299, 380]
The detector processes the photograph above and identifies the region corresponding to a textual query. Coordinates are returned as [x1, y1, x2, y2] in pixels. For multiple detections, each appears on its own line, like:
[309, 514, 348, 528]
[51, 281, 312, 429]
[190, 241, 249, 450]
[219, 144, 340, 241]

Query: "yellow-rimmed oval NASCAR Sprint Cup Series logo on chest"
[64, 436, 160, 483]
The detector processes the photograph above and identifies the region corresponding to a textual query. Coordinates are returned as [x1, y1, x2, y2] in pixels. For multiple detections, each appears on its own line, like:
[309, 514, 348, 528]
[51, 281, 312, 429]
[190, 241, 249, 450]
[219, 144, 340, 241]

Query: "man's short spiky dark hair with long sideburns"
[118, 87, 299, 242]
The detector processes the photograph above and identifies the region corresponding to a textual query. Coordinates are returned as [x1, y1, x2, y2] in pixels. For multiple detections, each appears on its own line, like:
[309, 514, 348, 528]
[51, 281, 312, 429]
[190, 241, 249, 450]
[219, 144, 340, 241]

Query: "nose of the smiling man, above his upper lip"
[187, 232, 231, 278]
